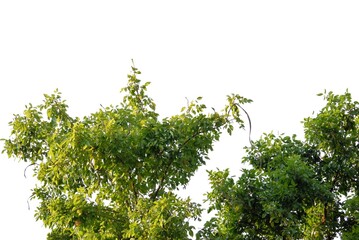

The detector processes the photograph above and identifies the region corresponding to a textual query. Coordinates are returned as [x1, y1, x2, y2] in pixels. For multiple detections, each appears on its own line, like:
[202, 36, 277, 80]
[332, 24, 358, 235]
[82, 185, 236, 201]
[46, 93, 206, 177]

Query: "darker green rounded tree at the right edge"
[197, 92, 359, 239]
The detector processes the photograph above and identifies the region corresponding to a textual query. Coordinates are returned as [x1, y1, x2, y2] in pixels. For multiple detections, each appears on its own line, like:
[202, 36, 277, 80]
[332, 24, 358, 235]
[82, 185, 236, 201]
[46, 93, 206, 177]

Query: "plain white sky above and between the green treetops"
[0, 0, 359, 240]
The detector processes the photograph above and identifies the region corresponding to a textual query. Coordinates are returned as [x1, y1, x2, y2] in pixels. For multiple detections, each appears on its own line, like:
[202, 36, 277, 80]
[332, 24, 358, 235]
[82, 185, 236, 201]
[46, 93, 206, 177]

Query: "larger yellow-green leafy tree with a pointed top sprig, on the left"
[4, 64, 250, 240]
